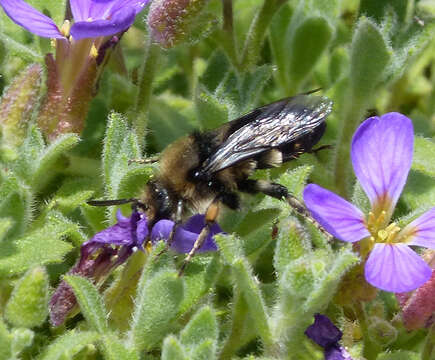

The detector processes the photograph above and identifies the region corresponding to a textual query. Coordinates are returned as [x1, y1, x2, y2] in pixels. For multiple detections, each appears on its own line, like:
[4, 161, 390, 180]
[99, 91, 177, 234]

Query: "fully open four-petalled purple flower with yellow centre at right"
[304, 113, 435, 293]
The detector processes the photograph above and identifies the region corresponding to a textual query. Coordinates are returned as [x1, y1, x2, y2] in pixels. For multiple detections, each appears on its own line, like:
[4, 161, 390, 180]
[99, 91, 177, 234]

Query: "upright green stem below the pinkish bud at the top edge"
[133, 38, 160, 147]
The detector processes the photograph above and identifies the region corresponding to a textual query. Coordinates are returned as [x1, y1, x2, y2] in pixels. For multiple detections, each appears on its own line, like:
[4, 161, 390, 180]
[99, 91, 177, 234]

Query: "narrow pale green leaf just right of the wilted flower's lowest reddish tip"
[64, 275, 108, 334]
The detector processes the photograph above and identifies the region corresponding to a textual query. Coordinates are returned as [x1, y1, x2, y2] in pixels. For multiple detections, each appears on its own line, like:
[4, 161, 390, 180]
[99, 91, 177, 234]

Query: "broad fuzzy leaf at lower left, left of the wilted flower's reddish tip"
[5, 267, 49, 328]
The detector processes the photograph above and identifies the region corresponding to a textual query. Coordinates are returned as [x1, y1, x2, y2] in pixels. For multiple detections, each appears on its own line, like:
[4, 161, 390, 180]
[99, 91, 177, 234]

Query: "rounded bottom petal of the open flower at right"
[365, 243, 432, 293]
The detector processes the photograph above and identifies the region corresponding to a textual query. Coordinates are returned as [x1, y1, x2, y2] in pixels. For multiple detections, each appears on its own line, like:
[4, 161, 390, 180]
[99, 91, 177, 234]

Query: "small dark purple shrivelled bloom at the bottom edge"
[305, 314, 352, 360]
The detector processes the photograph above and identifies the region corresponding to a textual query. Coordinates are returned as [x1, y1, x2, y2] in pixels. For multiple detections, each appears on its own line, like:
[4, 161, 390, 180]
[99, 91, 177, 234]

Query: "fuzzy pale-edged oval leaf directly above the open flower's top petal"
[350, 18, 392, 101]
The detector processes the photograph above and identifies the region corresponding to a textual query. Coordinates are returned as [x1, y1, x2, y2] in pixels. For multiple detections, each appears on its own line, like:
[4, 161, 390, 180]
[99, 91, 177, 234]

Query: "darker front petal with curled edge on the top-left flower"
[70, 8, 136, 40]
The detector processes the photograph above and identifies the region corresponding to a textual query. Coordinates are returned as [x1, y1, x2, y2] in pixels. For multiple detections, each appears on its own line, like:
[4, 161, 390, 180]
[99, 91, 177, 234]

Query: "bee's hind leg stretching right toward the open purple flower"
[238, 179, 333, 241]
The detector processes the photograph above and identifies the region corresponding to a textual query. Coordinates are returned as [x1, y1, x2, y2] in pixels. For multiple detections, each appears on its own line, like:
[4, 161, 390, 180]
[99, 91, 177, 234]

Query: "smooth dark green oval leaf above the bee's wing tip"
[289, 16, 333, 92]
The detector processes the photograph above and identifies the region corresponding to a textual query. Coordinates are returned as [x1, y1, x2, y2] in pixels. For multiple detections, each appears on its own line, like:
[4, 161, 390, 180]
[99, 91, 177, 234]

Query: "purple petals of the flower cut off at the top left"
[0, 0, 149, 40]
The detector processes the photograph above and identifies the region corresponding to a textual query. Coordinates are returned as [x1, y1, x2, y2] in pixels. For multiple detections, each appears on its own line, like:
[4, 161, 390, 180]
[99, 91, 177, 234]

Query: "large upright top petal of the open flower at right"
[351, 113, 414, 215]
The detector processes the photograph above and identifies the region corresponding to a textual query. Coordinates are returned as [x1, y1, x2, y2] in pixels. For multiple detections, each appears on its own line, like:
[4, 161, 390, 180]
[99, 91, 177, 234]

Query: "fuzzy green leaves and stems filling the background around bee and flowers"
[0, 0, 435, 360]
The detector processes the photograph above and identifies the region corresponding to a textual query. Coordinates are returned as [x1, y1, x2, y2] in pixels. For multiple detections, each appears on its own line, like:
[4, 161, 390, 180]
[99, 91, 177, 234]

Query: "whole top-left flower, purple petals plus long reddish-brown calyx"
[0, 0, 149, 140]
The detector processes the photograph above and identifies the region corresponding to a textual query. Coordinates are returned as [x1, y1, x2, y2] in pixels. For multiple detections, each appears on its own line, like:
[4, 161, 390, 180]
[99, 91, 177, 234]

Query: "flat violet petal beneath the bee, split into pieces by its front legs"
[151, 215, 222, 254]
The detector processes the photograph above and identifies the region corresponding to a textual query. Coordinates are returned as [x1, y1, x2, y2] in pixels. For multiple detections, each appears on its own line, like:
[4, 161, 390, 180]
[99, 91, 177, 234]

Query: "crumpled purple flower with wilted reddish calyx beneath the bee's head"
[50, 210, 222, 326]
